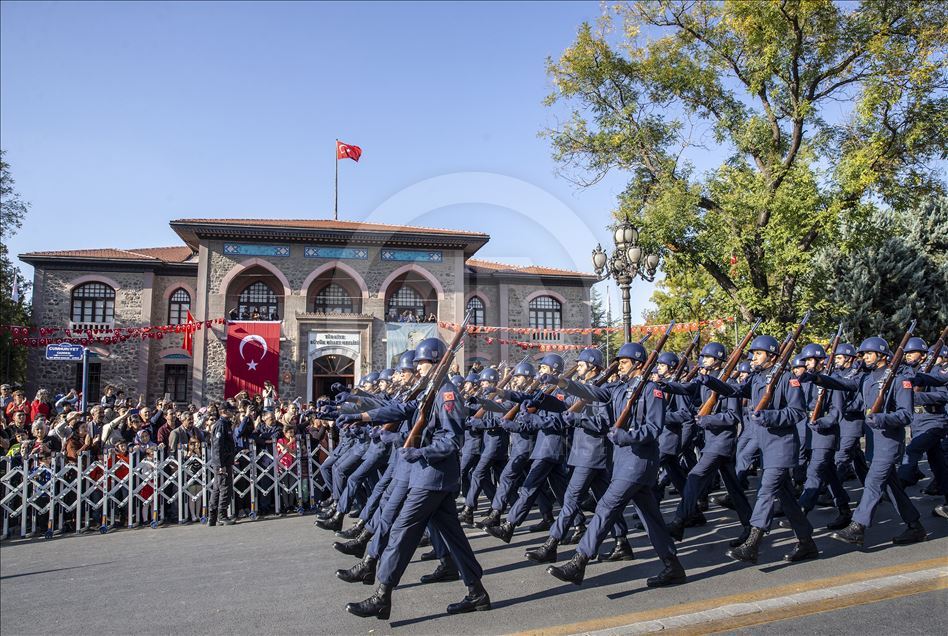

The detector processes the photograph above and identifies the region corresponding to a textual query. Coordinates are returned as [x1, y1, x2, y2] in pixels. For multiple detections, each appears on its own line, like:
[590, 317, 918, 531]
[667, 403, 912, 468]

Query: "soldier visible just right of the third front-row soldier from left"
[799, 343, 852, 530]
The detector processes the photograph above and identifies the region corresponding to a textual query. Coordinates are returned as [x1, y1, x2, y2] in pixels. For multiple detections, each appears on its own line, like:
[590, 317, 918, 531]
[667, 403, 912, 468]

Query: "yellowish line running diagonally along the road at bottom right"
[518, 557, 948, 636]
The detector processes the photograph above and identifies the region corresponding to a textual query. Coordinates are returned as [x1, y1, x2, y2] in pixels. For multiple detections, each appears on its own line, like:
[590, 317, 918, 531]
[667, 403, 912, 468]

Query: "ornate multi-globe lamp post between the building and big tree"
[592, 220, 659, 342]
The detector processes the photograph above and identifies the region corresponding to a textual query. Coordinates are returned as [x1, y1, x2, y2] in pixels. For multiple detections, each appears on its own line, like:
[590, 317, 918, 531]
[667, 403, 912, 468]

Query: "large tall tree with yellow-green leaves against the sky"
[546, 0, 948, 328]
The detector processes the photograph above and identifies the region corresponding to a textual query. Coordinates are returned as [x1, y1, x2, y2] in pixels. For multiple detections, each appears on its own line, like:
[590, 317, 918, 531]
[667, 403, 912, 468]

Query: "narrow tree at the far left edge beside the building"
[0, 150, 30, 382]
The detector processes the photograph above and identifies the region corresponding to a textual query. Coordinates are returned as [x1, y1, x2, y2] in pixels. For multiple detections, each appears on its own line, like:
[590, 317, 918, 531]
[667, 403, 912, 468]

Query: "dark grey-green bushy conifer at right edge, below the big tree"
[816, 197, 948, 343]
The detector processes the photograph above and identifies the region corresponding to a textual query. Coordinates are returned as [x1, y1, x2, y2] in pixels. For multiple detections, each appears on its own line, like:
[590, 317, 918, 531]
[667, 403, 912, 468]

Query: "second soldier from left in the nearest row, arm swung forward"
[547, 342, 686, 587]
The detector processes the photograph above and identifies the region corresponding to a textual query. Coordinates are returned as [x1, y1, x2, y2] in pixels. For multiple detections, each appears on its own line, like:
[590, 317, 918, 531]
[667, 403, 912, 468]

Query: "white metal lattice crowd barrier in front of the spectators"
[0, 435, 333, 539]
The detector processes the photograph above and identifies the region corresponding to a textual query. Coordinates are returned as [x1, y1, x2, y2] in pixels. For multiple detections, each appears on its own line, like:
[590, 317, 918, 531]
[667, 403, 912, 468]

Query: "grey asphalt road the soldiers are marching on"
[0, 482, 948, 636]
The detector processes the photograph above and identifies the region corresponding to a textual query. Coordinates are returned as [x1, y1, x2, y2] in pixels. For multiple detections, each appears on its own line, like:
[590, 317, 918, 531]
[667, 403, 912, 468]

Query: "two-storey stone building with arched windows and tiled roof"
[20, 219, 596, 403]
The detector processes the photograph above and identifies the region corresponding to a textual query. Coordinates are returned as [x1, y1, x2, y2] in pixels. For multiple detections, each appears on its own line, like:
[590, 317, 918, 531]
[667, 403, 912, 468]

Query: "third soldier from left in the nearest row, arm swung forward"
[699, 336, 819, 563]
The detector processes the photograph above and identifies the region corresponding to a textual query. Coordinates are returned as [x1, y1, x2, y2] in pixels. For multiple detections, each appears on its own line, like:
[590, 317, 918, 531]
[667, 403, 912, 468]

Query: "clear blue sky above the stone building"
[0, 2, 672, 321]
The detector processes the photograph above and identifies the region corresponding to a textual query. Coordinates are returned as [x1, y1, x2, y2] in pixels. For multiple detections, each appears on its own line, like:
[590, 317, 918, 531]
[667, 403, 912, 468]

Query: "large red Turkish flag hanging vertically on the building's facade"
[224, 321, 280, 398]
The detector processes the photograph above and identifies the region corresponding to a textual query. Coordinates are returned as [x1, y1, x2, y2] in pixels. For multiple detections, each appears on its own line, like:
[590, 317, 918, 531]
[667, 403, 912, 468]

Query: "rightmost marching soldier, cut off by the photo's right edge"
[898, 338, 948, 512]
